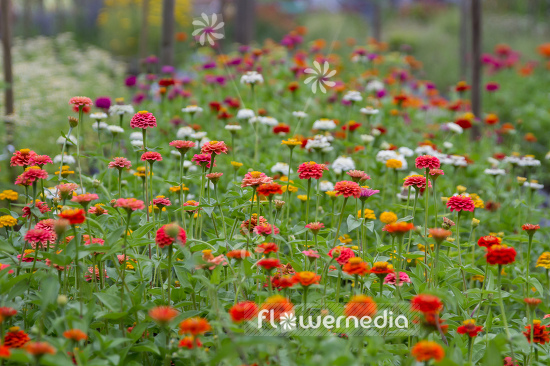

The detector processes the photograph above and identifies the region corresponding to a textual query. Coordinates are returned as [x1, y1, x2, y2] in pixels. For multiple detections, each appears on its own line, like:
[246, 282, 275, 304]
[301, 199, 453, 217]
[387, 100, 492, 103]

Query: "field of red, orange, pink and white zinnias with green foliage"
[0, 28, 550, 366]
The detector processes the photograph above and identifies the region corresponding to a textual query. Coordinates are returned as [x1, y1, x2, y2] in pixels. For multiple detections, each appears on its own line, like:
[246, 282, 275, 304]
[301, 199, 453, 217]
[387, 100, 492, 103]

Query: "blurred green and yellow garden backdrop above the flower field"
[4, 0, 550, 88]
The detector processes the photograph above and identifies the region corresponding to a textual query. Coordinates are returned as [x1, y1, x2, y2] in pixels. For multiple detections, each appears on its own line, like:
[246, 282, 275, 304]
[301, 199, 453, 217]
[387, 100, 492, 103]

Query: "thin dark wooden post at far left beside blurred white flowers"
[0, 0, 15, 176]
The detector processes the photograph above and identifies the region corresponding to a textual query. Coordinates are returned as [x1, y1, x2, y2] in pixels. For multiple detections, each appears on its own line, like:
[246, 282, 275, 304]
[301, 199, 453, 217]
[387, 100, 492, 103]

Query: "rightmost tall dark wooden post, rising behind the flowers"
[471, 0, 482, 138]
